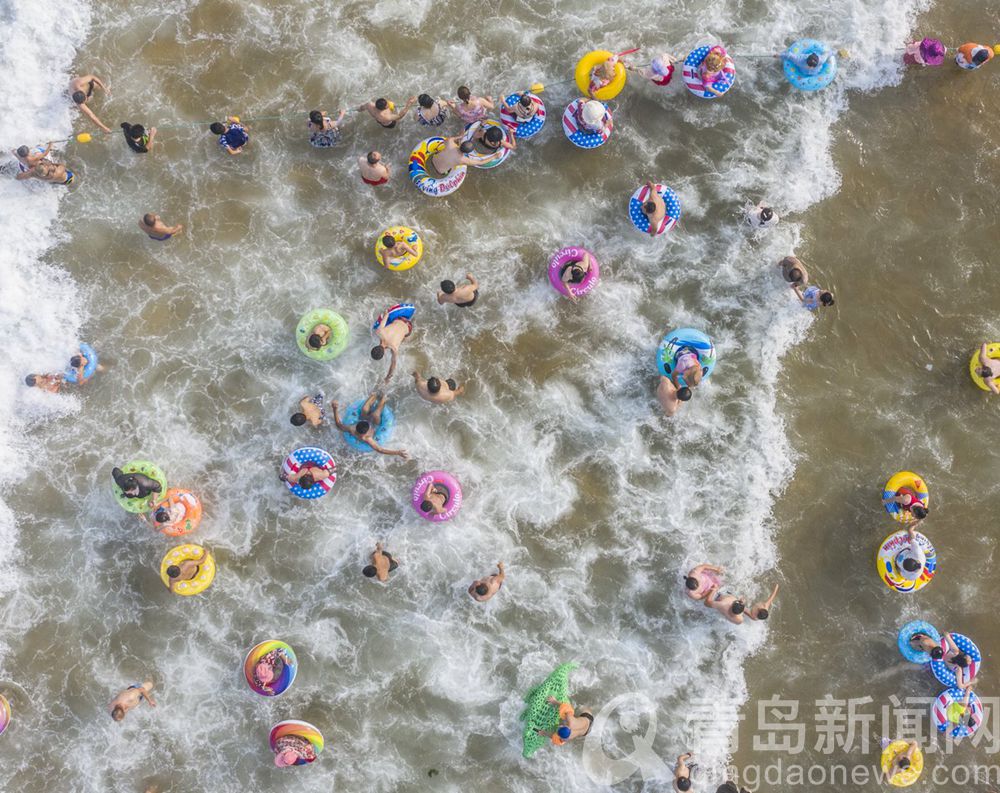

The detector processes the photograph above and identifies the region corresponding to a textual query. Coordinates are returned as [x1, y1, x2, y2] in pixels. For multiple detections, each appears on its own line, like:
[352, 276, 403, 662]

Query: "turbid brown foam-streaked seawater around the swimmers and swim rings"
[7, 0, 1000, 793]
